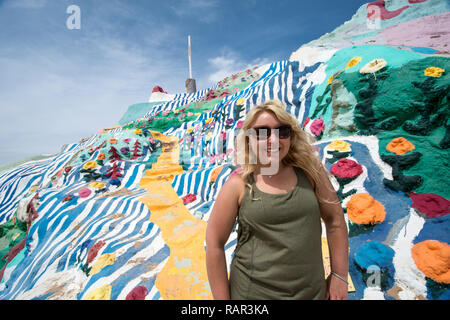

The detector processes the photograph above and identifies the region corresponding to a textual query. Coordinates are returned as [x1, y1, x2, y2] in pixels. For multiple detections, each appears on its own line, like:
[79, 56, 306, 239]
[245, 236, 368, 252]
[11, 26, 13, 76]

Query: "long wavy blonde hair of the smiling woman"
[235, 100, 335, 203]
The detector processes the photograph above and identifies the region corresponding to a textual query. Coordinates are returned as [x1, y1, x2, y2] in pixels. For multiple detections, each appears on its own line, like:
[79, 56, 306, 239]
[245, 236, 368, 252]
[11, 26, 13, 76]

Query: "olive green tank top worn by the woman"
[229, 167, 326, 300]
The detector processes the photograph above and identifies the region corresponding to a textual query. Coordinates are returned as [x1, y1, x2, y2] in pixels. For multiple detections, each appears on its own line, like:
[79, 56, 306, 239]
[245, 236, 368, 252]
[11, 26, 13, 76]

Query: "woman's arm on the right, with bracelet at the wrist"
[316, 167, 348, 300]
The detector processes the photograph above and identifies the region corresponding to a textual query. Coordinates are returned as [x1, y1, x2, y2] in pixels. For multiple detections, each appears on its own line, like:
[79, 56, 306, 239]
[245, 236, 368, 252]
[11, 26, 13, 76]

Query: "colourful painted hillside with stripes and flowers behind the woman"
[0, 0, 450, 300]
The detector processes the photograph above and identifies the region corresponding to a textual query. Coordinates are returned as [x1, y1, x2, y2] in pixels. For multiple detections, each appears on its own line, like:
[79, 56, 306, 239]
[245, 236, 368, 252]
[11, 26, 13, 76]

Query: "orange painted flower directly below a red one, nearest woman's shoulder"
[347, 193, 386, 225]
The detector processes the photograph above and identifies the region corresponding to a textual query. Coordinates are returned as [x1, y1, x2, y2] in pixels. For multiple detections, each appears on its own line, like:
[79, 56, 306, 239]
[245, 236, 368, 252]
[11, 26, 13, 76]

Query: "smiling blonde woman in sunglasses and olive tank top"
[206, 101, 348, 300]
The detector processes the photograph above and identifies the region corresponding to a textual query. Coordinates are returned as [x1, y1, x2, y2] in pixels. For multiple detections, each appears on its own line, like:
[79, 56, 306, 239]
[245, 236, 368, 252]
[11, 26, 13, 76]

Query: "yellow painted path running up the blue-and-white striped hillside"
[139, 131, 212, 300]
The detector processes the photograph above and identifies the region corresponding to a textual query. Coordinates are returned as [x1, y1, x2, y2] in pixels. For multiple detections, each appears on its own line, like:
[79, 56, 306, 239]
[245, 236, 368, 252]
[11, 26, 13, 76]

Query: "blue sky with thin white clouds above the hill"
[0, 0, 369, 166]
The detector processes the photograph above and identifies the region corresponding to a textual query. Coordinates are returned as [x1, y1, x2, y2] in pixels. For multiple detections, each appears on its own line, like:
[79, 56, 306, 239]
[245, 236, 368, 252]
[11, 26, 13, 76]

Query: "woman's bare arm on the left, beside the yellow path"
[206, 175, 245, 300]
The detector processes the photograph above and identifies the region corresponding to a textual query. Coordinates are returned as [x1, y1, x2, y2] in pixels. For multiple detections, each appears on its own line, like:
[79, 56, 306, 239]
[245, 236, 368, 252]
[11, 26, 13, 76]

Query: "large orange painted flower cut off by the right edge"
[411, 240, 450, 284]
